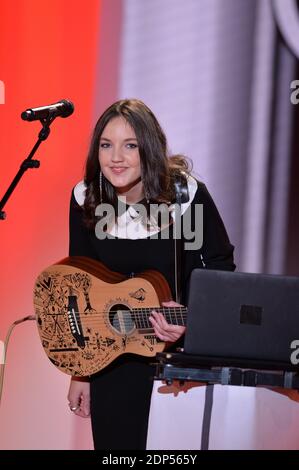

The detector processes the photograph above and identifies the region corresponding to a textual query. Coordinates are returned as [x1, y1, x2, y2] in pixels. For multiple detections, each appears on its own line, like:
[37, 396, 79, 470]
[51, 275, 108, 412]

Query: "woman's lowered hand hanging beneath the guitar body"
[67, 377, 90, 418]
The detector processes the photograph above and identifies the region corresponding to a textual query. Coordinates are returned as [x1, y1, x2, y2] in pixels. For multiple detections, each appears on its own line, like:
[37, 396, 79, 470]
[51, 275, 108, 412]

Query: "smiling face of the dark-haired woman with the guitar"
[99, 116, 141, 193]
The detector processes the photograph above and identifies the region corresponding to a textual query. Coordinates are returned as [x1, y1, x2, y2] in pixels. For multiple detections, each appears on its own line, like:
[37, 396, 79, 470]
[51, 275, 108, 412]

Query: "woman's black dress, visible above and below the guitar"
[69, 180, 235, 449]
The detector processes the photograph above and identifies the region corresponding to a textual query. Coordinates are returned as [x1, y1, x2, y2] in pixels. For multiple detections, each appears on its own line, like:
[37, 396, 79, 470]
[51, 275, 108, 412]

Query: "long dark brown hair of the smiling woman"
[83, 99, 190, 227]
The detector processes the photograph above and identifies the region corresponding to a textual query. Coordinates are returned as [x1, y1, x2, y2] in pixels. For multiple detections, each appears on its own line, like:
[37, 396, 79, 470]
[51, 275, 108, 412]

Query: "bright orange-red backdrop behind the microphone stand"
[0, 0, 100, 330]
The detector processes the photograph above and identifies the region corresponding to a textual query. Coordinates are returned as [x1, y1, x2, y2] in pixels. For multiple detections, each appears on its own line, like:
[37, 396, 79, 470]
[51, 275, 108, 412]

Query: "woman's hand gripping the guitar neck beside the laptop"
[149, 300, 186, 343]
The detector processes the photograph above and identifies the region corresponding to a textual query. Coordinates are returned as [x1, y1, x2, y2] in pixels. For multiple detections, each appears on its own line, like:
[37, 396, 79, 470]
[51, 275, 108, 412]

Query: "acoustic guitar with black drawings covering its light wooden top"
[34, 256, 187, 376]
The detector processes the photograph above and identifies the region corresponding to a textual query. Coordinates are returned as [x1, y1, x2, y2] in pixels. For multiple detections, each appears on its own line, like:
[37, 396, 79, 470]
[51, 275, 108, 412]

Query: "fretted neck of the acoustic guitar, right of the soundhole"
[131, 307, 187, 329]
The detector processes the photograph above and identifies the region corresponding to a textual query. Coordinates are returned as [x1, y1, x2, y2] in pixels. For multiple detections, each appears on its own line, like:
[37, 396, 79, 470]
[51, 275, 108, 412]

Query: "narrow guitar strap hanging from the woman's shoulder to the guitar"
[174, 173, 189, 303]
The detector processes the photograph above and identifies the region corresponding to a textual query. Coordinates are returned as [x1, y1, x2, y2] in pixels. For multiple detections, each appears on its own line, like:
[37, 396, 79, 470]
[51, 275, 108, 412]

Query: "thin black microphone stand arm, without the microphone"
[0, 111, 56, 220]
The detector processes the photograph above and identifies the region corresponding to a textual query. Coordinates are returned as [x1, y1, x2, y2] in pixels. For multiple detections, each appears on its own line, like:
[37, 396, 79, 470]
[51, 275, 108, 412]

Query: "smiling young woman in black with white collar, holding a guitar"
[68, 99, 235, 449]
